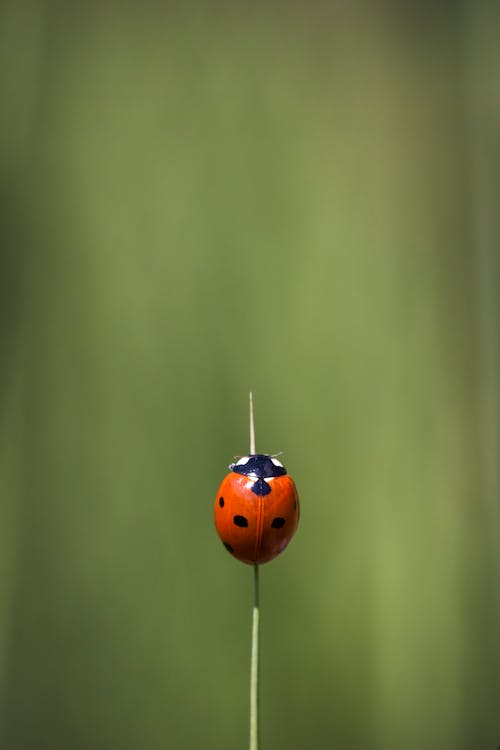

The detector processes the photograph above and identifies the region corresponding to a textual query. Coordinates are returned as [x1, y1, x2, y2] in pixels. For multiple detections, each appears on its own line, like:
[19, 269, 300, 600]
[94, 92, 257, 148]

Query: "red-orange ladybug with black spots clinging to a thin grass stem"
[214, 453, 300, 565]
